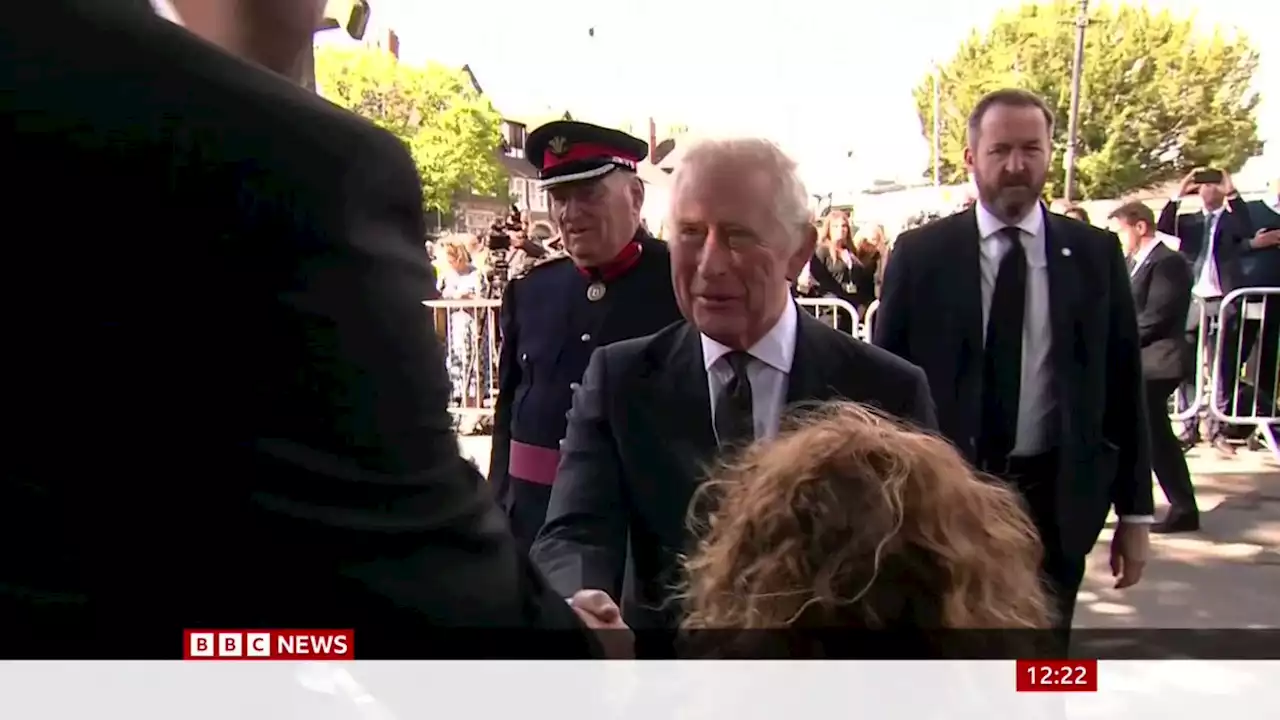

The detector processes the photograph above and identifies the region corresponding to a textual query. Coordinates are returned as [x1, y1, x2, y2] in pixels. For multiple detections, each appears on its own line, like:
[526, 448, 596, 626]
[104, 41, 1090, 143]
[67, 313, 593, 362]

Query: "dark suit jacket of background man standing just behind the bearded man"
[1129, 242, 1194, 380]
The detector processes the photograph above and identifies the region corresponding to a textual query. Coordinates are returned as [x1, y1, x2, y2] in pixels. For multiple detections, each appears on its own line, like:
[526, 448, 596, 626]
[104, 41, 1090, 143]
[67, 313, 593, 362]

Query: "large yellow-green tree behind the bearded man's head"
[915, 0, 1262, 199]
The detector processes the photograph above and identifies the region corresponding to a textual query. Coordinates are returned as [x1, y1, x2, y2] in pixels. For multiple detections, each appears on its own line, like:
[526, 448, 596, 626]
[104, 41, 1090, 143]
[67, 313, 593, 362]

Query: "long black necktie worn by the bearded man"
[979, 228, 1027, 464]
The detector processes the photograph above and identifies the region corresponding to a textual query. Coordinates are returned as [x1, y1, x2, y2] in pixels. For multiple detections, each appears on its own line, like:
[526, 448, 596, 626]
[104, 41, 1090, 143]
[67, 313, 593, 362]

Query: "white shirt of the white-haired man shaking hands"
[701, 302, 799, 439]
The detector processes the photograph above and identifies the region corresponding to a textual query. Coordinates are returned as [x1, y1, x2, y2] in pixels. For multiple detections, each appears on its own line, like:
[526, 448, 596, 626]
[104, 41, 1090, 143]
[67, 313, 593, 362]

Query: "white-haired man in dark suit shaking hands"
[532, 134, 934, 655]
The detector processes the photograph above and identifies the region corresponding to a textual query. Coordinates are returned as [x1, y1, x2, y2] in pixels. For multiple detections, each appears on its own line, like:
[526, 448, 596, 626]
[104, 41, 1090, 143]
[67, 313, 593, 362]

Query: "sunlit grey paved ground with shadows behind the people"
[462, 437, 1280, 628]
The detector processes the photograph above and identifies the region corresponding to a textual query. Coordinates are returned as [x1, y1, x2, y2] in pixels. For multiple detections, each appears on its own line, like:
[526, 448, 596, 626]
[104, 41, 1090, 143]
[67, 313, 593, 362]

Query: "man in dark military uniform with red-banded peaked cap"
[489, 120, 681, 551]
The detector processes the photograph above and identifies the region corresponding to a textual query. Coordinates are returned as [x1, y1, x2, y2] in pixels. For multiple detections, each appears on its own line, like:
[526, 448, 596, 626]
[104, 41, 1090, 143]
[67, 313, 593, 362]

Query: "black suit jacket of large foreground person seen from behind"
[0, 0, 588, 657]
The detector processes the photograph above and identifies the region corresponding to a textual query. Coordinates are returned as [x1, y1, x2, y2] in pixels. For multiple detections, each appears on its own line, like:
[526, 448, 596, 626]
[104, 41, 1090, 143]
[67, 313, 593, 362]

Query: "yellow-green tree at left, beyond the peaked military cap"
[315, 47, 506, 211]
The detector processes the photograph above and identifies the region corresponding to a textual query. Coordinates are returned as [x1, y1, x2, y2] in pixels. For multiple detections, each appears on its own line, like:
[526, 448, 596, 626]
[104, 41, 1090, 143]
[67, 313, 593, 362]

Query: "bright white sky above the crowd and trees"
[372, 0, 1280, 191]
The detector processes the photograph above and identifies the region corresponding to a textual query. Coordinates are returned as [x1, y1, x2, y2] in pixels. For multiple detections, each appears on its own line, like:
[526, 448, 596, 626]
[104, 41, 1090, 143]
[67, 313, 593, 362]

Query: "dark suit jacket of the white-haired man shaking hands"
[532, 311, 936, 628]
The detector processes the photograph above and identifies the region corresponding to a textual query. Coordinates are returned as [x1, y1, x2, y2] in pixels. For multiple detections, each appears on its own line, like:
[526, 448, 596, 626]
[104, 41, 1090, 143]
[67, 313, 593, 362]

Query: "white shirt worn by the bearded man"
[977, 202, 1057, 457]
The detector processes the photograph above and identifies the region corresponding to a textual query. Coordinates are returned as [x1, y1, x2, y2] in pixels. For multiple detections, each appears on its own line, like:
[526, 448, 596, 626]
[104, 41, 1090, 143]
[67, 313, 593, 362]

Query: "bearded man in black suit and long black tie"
[874, 90, 1155, 637]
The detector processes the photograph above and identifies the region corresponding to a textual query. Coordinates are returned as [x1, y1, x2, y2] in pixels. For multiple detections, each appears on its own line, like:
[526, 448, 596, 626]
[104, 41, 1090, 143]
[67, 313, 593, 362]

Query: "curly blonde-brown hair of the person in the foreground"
[681, 402, 1052, 630]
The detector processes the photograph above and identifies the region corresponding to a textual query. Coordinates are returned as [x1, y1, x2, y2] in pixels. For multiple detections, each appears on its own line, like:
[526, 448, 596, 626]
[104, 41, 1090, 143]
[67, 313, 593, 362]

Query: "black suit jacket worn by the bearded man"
[873, 208, 1153, 557]
